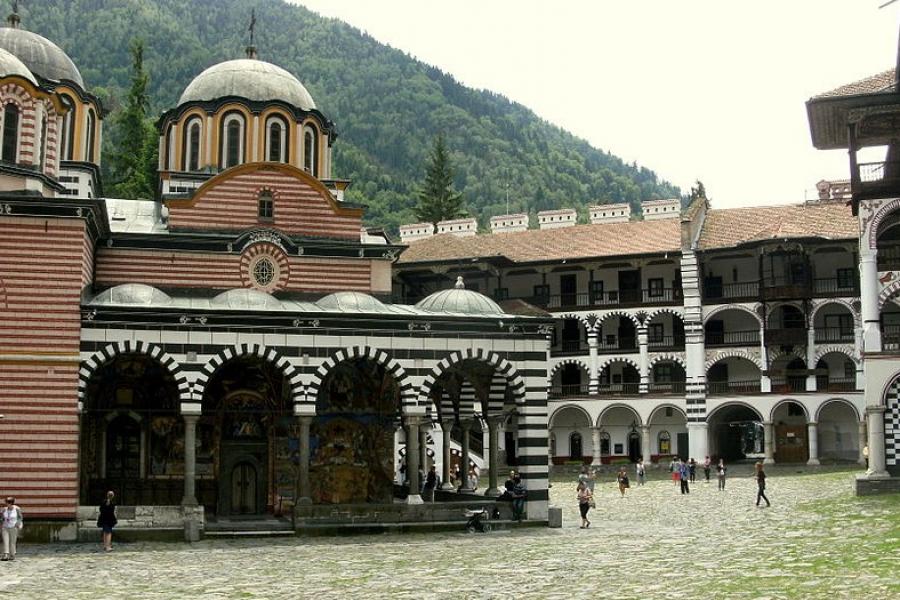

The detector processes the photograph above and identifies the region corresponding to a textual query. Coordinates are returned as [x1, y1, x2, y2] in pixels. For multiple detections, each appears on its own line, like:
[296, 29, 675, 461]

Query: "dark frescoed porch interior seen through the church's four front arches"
[80, 354, 516, 517]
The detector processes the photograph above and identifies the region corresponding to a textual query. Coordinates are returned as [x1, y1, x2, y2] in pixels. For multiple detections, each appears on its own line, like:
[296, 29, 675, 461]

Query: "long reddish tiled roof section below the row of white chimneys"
[399, 218, 681, 264]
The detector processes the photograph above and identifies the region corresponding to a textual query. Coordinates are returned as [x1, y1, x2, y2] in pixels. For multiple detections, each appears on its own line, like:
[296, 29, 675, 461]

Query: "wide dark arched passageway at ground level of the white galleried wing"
[707, 404, 764, 462]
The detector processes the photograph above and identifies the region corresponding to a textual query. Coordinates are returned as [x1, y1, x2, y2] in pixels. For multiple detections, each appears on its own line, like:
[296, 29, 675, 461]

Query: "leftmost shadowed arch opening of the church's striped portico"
[79, 354, 184, 505]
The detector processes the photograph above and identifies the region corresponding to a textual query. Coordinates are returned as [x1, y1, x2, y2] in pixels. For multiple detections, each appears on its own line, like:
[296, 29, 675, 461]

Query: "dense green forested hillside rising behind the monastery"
[20, 0, 679, 231]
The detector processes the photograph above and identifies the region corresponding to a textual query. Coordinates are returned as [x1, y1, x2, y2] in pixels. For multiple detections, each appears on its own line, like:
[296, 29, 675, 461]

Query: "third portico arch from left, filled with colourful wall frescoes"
[310, 358, 400, 504]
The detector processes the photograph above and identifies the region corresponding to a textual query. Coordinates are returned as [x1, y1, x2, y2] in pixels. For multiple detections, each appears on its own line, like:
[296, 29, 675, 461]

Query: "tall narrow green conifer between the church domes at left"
[112, 40, 158, 199]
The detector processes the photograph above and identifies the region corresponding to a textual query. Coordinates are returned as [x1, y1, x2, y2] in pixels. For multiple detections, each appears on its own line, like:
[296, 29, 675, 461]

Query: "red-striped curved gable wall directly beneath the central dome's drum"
[168, 164, 362, 240]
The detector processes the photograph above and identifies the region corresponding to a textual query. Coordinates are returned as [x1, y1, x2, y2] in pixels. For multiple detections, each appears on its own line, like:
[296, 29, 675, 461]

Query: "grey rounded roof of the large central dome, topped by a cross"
[178, 58, 316, 110]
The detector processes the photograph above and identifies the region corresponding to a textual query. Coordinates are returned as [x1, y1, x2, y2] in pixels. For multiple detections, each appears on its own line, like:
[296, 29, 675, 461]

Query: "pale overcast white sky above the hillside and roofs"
[291, 0, 900, 208]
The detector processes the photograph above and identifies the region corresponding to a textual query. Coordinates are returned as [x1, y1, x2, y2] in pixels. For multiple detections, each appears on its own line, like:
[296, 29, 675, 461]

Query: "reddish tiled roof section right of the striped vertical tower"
[700, 202, 859, 250]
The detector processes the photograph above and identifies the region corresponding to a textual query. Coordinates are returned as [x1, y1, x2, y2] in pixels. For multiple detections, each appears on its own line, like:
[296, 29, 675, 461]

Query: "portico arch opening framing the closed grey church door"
[202, 356, 299, 516]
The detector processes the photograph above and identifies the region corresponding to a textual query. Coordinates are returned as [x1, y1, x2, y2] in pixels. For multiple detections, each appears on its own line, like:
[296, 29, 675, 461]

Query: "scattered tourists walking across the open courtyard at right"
[576, 456, 772, 529]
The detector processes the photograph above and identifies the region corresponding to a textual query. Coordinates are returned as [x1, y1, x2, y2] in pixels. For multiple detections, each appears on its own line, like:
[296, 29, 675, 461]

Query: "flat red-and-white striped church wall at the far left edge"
[0, 217, 90, 518]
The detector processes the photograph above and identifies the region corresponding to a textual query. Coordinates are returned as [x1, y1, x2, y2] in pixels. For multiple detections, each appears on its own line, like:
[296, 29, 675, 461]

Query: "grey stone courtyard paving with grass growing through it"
[0, 468, 900, 600]
